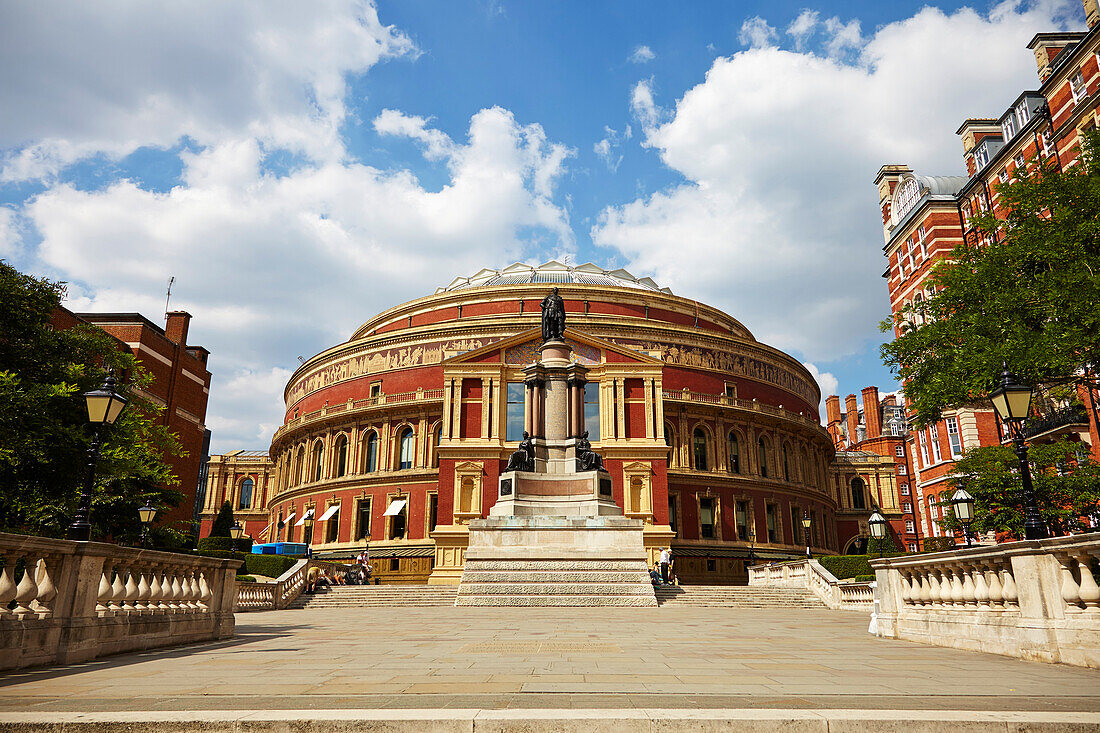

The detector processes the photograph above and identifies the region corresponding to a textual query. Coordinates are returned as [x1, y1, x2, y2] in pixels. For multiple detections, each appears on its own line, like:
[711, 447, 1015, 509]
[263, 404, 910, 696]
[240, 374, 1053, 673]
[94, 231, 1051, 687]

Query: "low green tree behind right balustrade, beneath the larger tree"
[938, 440, 1100, 538]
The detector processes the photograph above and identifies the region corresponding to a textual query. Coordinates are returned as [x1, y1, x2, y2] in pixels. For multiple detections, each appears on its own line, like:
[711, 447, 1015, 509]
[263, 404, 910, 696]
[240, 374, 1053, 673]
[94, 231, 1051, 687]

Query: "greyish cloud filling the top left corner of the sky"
[0, 0, 414, 180]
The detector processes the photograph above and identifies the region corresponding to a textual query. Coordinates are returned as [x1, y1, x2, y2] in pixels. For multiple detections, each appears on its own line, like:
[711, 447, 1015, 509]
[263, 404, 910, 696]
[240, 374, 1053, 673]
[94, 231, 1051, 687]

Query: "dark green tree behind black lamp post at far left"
[0, 261, 183, 541]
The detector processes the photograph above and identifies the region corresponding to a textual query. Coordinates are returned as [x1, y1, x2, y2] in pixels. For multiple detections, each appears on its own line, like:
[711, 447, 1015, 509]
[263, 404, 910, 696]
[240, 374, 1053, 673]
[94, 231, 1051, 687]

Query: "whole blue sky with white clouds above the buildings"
[0, 0, 1084, 452]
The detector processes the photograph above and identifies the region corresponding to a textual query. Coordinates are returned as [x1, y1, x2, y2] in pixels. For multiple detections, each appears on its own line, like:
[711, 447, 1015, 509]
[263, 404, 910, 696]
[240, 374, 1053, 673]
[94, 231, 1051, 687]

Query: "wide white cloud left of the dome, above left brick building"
[24, 108, 573, 450]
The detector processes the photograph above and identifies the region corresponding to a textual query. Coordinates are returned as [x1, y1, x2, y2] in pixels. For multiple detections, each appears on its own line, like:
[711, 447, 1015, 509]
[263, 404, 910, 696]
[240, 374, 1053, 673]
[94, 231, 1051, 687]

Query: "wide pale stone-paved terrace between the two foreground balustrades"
[0, 608, 1100, 713]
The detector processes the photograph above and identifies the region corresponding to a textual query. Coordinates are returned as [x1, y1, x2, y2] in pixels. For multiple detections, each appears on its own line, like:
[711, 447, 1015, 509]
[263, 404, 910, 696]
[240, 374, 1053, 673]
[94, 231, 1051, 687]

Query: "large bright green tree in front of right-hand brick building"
[881, 131, 1100, 426]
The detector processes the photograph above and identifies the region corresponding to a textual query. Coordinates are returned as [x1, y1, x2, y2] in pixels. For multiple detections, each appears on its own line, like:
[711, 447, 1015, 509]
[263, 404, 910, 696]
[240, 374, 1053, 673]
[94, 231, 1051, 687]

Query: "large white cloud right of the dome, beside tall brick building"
[591, 0, 1079, 363]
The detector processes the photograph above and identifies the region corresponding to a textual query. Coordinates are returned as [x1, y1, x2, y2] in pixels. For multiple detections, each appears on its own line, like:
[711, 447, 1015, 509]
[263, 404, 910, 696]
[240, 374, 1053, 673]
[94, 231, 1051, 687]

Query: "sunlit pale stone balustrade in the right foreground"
[871, 533, 1100, 668]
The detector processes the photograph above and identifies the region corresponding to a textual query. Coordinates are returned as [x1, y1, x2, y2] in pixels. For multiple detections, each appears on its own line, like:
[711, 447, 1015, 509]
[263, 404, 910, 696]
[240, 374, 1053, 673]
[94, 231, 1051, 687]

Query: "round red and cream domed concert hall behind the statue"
[207, 262, 842, 583]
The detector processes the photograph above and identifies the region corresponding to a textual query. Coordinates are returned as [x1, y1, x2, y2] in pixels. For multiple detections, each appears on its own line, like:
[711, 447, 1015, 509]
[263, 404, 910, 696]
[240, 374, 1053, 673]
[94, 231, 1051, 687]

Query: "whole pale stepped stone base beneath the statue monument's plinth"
[454, 516, 657, 606]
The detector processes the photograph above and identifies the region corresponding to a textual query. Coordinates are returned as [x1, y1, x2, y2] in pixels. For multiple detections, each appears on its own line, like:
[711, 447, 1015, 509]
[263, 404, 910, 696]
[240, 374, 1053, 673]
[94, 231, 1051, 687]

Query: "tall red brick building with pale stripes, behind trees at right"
[875, 0, 1100, 537]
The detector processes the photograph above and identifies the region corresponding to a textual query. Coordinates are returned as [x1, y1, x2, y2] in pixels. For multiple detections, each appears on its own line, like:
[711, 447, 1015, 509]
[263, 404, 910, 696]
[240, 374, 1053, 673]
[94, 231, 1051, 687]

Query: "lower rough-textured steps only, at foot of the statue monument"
[455, 556, 657, 606]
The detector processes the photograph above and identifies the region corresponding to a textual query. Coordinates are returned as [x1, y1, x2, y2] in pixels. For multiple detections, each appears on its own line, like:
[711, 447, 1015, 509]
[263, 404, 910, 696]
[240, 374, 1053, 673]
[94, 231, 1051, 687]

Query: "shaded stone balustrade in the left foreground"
[0, 533, 241, 669]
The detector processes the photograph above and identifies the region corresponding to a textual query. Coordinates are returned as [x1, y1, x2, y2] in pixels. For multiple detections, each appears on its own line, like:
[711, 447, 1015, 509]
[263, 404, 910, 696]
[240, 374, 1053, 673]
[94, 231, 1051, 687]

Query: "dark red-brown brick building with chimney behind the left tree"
[53, 308, 210, 522]
